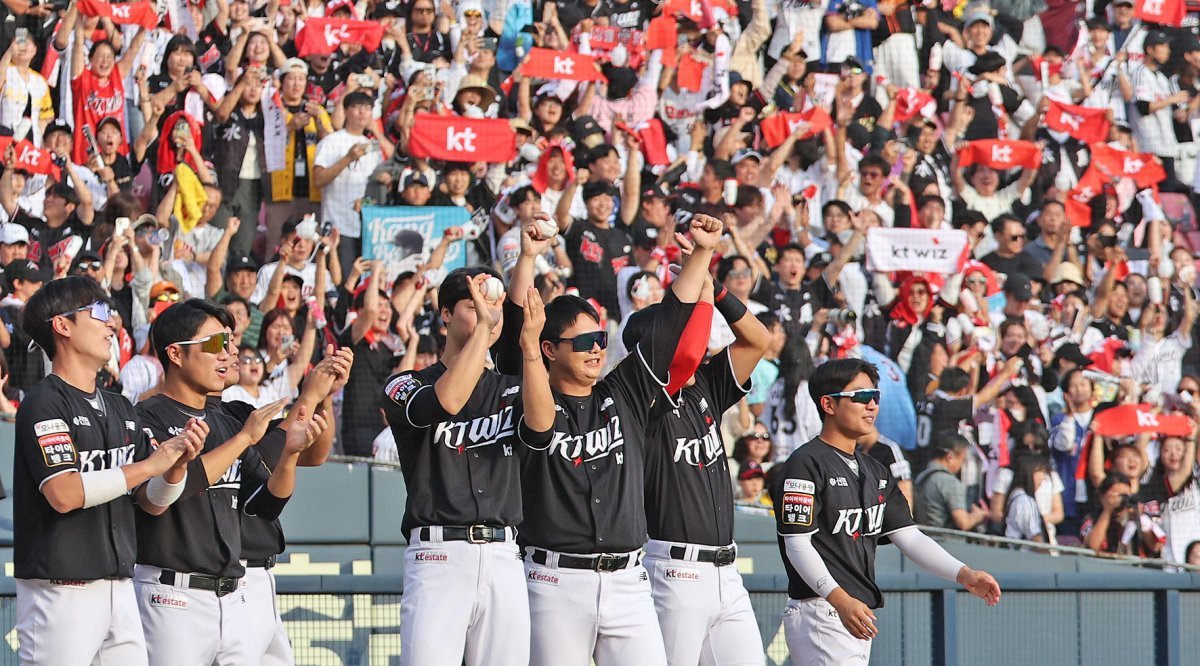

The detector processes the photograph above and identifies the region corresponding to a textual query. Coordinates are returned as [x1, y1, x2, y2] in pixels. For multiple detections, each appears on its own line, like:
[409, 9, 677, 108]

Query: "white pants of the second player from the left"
[133, 564, 254, 666]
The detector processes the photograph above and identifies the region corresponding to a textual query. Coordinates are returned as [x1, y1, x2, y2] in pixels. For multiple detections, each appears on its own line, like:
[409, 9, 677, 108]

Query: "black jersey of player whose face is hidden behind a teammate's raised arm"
[646, 349, 750, 546]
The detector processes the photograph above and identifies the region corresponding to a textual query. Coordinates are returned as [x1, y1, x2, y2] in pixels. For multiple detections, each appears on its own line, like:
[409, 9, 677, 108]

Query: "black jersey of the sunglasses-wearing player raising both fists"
[516, 292, 695, 554]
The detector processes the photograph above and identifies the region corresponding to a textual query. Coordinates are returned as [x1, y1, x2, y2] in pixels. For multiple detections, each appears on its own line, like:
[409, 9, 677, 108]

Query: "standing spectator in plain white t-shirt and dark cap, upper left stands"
[312, 91, 379, 273]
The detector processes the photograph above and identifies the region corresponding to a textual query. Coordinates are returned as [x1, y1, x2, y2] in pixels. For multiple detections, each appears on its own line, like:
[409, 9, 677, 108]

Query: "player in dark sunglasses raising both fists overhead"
[505, 215, 721, 666]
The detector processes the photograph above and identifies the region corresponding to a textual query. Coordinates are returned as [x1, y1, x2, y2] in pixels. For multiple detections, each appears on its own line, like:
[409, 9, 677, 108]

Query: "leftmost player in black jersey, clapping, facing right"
[13, 277, 205, 666]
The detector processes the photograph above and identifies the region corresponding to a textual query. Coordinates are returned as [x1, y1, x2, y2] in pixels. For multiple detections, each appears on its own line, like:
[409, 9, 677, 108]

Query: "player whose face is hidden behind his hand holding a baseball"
[382, 266, 544, 666]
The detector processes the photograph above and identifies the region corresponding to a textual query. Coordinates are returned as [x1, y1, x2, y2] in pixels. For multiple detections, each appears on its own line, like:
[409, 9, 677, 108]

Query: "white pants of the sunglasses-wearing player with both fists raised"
[524, 548, 667, 666]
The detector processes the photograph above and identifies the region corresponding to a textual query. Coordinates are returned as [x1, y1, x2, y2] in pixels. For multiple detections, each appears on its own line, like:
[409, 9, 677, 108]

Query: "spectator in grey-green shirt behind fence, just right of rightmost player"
[913, 434, 988, 532]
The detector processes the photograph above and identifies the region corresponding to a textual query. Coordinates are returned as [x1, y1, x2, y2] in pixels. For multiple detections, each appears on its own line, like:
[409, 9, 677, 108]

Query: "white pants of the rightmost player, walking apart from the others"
[784, 598, 871, 666]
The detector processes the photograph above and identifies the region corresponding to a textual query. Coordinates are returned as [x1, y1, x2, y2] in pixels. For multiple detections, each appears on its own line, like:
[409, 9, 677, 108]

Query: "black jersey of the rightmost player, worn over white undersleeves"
[770, 438, 914, 608]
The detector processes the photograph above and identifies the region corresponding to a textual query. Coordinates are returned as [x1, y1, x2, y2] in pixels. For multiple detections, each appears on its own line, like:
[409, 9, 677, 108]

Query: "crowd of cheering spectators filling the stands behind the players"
[0, 0, 1200, 564]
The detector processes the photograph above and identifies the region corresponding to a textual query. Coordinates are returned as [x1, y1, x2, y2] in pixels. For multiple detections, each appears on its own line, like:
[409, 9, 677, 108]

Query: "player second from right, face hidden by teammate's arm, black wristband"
[643, 272, 770, 666]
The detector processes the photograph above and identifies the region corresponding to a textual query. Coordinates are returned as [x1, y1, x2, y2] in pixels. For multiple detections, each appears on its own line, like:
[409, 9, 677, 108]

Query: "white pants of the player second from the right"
[644, 539, 767, 666]
